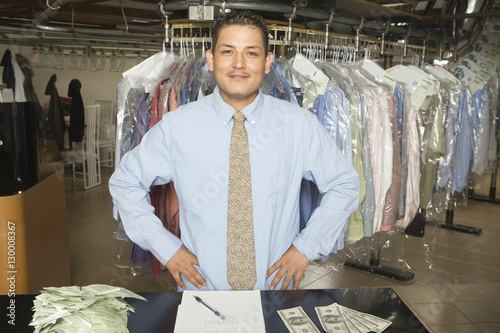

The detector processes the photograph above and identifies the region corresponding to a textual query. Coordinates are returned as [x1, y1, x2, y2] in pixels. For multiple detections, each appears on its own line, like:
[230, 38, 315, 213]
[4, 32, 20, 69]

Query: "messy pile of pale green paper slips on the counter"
[30, 284, 146, 333]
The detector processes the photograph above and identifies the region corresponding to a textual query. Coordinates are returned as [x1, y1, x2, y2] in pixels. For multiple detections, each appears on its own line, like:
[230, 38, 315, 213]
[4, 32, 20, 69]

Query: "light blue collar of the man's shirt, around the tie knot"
[213, 86, 264, 127]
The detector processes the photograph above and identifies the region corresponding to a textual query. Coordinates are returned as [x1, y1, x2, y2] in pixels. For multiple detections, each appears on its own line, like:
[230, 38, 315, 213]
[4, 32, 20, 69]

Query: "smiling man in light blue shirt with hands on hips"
[109, 12, 359, 290]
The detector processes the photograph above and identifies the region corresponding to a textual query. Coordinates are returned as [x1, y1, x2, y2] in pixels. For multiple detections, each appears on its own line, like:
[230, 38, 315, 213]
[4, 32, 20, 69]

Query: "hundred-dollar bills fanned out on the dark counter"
[278, 303, 391, 333]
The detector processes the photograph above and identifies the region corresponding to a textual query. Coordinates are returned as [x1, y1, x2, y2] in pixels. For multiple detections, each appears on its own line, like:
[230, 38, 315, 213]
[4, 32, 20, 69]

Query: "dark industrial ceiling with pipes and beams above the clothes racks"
[0, 0, 500, 56]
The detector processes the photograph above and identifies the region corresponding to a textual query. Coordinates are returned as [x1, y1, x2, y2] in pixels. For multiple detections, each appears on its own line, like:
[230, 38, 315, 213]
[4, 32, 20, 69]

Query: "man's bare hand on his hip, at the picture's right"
[266, 245, 309, 290]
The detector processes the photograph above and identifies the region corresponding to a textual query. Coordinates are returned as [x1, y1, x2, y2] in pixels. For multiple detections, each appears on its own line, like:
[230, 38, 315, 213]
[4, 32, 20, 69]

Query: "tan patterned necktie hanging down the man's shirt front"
[227, 111, 257, 290]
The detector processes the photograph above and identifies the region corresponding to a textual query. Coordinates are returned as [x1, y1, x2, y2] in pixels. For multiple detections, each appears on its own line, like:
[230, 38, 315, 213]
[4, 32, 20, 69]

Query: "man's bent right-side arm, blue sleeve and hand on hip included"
[267, 111, 359, 290]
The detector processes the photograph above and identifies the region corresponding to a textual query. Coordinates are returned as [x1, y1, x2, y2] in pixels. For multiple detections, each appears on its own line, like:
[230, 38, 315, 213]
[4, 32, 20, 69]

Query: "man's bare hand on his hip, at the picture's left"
[165, 245, 207, 289]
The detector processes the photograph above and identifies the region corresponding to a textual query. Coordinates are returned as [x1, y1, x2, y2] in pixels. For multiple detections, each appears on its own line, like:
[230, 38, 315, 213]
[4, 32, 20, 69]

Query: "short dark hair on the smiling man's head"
[212, 10, 269, 52]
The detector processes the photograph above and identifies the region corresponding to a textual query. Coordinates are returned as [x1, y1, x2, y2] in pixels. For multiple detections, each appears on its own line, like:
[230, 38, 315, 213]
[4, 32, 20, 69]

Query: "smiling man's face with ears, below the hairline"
[206, 25, 273, 110]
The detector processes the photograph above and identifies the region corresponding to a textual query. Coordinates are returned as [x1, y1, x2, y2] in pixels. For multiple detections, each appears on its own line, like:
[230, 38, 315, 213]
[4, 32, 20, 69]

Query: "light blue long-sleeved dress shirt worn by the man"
[109, 87, 359, 290]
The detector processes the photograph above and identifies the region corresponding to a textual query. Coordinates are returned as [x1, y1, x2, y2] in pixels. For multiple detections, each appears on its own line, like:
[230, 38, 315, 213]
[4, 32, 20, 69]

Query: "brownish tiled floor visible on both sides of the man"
[66, 169, 500, 333]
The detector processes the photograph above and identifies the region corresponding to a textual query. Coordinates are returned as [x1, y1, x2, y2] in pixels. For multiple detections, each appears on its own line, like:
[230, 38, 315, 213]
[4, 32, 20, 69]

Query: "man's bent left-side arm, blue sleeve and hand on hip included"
[109, 119, 206, 288]
